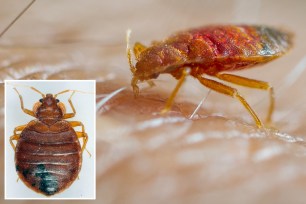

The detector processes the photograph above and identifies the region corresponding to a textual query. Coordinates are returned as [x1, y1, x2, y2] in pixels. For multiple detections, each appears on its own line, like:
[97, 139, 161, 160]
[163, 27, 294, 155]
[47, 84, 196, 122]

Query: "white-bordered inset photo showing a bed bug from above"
[4, 80, 96, 199]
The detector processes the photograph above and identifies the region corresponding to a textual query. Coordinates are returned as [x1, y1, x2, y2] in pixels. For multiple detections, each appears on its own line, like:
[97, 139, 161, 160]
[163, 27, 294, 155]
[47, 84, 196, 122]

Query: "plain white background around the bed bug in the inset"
[5, 80, 96, 199]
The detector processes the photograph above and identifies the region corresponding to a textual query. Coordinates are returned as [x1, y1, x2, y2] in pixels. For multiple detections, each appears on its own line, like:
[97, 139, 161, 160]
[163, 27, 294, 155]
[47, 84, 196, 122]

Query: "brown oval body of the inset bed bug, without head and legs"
[15, 120, 82, 196]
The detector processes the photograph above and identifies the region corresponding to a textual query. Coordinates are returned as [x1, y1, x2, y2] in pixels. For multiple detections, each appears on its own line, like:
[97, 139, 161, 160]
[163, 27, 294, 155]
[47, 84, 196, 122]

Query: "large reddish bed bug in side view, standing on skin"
[127, 25, 292, 128]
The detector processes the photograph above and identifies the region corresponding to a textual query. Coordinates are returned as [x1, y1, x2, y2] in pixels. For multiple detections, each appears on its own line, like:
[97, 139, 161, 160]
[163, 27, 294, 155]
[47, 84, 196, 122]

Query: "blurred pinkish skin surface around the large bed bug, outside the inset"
[0, 0, 306, 203]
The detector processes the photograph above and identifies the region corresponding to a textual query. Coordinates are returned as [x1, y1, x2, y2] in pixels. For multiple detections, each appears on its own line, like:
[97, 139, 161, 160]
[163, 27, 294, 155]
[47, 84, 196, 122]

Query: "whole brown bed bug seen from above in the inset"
[10, 87, 90, 196]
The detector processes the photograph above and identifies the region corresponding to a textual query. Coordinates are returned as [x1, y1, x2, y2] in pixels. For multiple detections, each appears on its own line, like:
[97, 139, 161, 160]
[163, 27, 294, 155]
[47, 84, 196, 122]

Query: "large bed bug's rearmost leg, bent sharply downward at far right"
[216, 74, 275, 124]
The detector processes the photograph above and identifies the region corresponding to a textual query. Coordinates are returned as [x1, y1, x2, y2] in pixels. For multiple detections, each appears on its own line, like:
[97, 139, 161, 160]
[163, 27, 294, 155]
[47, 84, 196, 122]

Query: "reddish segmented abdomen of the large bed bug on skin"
[169, 25, 292, 74]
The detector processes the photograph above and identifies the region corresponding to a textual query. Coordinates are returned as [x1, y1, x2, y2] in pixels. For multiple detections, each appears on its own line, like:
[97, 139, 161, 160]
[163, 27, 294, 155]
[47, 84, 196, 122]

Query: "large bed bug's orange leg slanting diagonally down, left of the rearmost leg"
[197, 76, 263, 128]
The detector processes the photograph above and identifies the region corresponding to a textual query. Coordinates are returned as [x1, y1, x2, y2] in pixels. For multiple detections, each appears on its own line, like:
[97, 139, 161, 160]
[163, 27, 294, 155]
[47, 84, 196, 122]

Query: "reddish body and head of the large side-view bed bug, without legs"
[135, 25, 292, 80]
